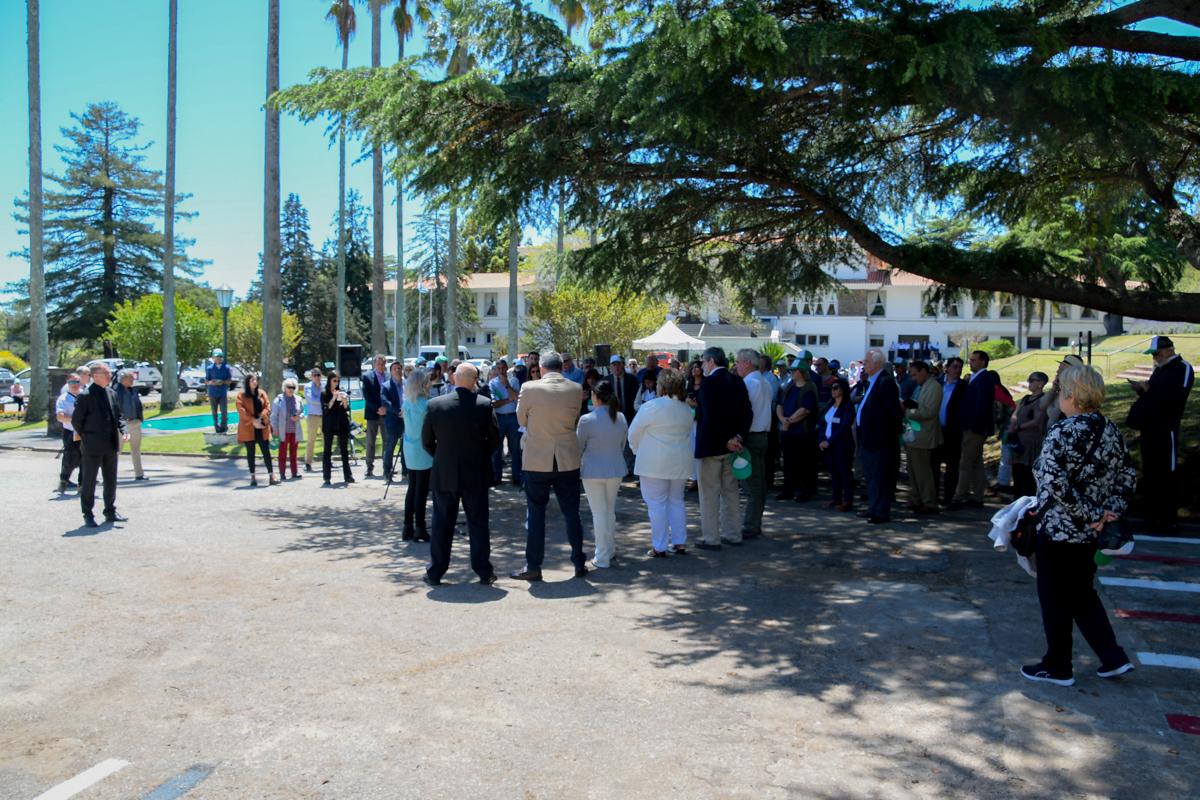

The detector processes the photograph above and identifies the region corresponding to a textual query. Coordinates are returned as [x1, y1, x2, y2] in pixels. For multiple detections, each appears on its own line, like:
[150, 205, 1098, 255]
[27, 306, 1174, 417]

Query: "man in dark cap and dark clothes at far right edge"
[1126, 336, 1195, 533]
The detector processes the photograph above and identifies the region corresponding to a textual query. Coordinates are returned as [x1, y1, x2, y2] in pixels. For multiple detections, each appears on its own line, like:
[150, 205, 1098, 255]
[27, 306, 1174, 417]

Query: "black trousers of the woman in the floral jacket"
[1036, 536, 1129, 673]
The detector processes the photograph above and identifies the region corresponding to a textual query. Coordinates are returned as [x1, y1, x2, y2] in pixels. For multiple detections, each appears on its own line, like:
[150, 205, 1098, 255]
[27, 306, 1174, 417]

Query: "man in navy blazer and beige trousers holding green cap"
[695, 348, 754, 551]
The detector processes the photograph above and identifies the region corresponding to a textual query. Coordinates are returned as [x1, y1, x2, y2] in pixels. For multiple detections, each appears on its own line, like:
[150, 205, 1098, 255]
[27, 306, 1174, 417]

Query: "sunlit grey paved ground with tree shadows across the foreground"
[0, 451, 1200, 800]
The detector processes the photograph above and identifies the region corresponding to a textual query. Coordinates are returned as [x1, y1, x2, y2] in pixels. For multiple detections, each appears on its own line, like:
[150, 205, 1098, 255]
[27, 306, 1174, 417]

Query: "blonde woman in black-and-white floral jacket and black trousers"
[1021, 366, 1138, 686]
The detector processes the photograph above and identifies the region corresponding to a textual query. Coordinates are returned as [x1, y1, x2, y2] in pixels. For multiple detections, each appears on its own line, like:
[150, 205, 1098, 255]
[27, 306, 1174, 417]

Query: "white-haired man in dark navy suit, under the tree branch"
[854, 348, 904, 524]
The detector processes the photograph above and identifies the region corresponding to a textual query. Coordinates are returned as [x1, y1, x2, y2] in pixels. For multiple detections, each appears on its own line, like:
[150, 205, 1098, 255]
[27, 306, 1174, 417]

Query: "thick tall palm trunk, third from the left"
[260, 0, 283, 396]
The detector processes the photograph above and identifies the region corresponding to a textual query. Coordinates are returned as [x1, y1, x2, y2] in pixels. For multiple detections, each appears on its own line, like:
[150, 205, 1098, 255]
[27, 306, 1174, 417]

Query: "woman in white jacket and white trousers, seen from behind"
[629, 369, 694, 558]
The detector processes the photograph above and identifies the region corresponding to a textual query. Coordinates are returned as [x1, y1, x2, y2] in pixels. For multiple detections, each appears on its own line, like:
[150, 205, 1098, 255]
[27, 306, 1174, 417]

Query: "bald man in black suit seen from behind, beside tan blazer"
[421, 363, 500, 587]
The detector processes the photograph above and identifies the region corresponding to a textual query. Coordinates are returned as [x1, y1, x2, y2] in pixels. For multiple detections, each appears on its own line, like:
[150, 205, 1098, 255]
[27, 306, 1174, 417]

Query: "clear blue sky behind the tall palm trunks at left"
[0, 0, 446, 302]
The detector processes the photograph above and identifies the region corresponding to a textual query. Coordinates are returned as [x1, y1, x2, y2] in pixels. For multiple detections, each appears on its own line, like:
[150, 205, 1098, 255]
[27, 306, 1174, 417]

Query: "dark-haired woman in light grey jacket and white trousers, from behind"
[575, 381, 626, 570]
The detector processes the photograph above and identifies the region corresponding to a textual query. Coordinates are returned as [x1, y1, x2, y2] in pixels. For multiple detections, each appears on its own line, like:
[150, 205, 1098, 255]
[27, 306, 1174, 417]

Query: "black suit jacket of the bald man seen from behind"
[421, 389, 500, 492]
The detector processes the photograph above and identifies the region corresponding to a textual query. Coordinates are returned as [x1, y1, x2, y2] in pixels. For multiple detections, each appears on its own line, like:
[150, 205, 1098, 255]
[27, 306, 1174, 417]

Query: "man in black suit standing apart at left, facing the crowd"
[71, 363, 130, 528]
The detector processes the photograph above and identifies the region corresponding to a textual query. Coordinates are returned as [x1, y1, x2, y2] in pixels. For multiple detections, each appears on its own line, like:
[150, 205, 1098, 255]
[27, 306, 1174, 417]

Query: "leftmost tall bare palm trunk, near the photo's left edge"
[25, 0, 50, 422]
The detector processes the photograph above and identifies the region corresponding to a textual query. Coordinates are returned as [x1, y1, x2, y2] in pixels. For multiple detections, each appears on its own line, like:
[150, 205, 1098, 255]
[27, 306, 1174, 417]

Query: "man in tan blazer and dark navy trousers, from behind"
[512, 353, 588, 581]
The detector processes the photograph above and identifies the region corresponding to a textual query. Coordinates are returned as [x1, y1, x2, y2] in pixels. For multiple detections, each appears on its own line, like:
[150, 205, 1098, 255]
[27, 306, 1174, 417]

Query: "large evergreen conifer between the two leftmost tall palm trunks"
[14, 103, 199, 341]
